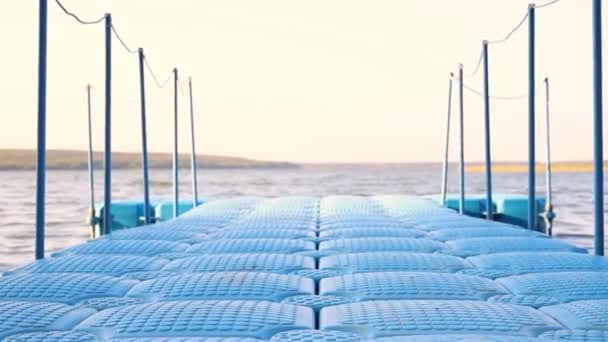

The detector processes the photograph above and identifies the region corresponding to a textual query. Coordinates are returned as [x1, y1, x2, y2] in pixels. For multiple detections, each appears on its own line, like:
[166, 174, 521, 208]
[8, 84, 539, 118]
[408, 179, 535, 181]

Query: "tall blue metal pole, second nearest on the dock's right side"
[528, 4, 536, 229]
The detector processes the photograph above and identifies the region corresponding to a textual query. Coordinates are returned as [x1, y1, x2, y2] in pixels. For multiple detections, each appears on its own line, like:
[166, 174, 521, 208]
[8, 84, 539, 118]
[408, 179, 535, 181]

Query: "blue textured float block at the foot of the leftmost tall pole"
[12, 255, 168, 276]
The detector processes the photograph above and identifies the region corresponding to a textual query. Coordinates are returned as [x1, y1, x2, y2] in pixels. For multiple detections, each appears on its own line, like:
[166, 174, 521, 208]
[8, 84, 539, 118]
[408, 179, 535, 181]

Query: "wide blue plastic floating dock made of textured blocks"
[0, 196, 608, 342]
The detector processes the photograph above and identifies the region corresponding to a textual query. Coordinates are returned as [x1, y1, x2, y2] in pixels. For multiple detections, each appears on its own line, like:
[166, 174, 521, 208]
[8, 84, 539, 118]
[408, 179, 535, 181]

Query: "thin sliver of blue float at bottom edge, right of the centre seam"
[373, 335, 553, 342]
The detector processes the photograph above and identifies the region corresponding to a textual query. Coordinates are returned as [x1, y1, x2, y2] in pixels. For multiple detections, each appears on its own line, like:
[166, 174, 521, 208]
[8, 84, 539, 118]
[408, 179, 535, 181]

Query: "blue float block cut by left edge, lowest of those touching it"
[0, 301, 96, 339]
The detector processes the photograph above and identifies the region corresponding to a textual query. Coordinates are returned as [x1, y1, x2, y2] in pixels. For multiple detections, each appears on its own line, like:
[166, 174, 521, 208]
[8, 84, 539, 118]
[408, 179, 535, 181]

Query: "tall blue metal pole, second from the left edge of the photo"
[103, 13, 112, 234]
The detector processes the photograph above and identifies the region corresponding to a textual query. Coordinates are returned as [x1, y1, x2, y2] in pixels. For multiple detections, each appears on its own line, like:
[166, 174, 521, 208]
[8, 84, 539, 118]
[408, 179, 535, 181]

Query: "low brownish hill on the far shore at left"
[0, 149, 298, 170]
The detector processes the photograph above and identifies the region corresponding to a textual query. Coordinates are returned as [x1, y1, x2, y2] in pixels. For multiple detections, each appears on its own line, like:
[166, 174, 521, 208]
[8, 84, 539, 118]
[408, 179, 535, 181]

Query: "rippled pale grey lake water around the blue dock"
[0, 165, 604, 271]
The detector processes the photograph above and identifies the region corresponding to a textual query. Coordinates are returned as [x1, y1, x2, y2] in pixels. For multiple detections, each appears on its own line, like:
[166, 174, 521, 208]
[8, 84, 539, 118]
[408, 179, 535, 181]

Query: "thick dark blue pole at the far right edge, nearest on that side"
[593, 0, 604, 255]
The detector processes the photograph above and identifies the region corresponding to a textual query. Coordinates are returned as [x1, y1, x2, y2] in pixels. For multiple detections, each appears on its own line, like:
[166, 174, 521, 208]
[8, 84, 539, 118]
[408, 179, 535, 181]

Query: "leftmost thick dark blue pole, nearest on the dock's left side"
[36, 0, 48, 259]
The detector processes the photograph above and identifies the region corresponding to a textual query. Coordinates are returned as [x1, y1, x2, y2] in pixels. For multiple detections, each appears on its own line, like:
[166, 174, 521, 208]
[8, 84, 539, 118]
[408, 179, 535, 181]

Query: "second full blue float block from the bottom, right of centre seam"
[319, 272, 507, 301]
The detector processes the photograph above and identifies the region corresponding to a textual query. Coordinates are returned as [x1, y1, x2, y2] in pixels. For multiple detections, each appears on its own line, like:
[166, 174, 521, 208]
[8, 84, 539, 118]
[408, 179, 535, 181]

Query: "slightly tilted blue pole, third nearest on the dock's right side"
[483, 40, 494, 221]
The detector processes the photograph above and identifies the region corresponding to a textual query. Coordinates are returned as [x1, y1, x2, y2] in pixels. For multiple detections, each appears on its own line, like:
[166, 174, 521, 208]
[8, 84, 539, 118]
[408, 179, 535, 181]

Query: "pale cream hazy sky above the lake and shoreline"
[0, 0, 608, 162]
